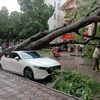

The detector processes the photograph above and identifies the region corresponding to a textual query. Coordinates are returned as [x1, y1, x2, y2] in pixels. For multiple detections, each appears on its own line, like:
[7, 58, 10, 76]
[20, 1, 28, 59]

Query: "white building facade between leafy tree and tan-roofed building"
[44, 0, 67, 30]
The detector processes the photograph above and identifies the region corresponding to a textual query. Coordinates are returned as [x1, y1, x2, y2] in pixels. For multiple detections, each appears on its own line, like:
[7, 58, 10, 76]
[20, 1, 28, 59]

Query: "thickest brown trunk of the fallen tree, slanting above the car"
[18, 16, 100, 50]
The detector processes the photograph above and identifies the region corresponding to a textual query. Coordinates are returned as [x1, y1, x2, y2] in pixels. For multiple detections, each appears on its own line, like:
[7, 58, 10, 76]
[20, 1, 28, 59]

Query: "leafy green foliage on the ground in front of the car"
[47, 69, 100, 100]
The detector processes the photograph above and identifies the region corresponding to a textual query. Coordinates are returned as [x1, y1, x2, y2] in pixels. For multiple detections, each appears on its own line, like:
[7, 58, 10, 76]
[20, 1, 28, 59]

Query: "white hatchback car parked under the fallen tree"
[1, 51, 61, 80]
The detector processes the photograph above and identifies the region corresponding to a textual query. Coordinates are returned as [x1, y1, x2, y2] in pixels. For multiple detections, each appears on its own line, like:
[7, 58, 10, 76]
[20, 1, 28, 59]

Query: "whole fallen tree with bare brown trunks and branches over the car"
[0, 7, 100, 56]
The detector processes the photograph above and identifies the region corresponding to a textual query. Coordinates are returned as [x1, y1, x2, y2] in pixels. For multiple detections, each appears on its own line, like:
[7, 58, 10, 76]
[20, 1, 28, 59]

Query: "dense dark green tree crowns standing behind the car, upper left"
[0, 0, 54, 40]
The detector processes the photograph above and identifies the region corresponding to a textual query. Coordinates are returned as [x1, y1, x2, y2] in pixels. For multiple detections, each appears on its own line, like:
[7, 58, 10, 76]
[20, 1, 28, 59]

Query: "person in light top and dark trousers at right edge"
[93, 45, 100, 71]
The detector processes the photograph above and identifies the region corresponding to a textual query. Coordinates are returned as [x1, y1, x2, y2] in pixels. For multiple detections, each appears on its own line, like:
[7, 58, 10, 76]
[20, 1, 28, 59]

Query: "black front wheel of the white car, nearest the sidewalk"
[24, 67, 34, 80]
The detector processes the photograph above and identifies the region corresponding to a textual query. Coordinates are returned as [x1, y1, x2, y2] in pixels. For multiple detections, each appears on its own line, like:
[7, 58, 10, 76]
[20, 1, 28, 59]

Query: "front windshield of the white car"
[20, 52, 41, 59]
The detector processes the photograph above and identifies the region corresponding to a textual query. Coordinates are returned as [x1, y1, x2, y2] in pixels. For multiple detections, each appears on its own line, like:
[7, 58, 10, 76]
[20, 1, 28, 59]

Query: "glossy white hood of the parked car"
[27, 57, 60, 67]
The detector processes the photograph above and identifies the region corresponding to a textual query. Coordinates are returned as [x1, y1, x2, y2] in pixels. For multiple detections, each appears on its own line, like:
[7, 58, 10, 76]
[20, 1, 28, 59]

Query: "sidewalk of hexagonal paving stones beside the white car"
[0, 70, 79, 100]
